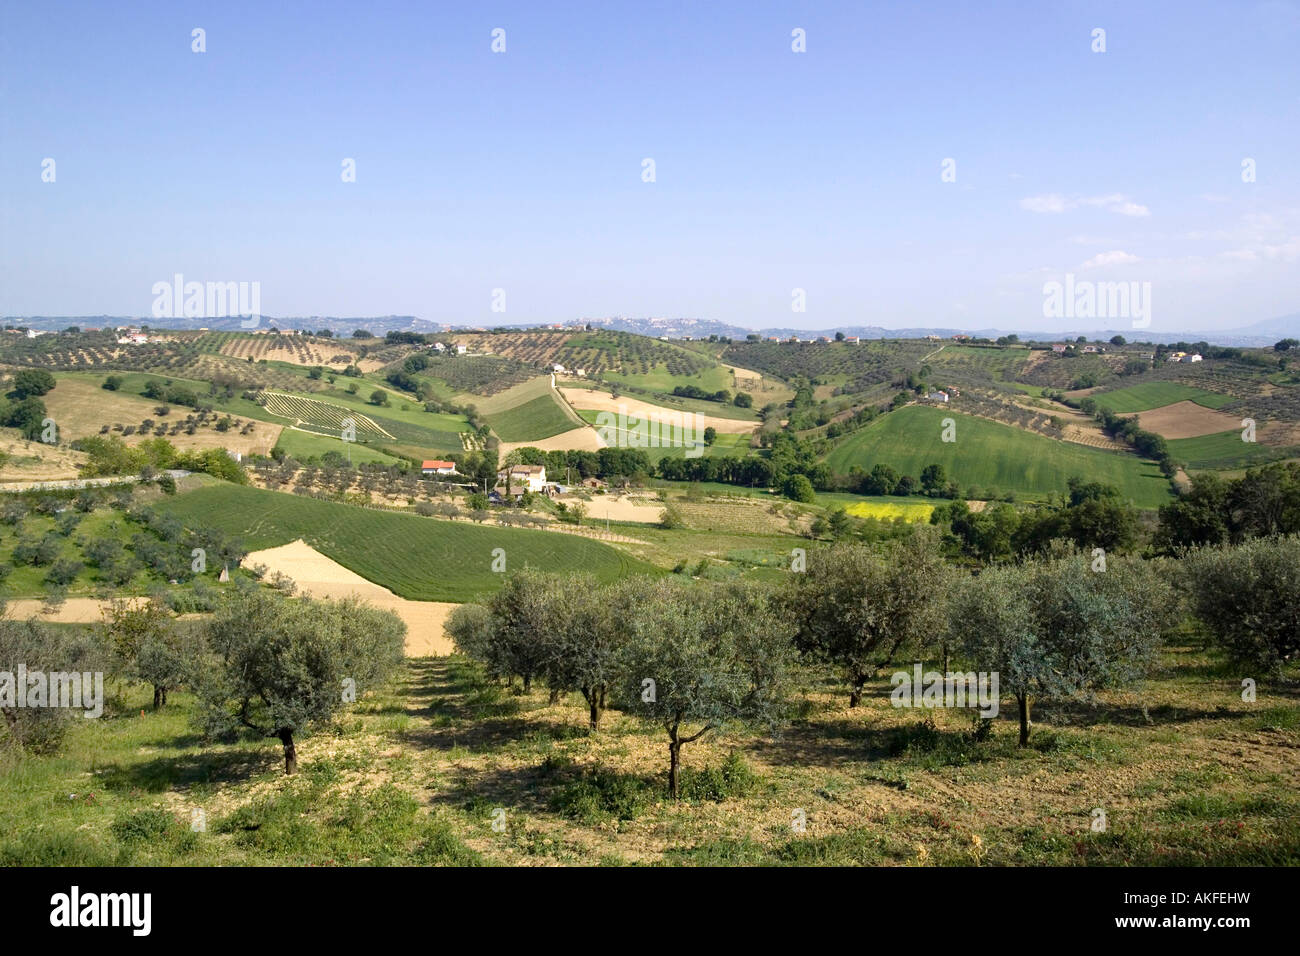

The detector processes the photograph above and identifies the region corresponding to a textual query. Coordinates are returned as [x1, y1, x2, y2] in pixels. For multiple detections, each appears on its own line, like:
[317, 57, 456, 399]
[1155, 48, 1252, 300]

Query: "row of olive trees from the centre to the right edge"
[449, 529, 1300, 792]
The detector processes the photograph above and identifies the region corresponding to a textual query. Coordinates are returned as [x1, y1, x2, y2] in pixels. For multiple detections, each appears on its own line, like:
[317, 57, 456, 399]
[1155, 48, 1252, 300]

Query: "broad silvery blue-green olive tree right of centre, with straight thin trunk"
[948, 554, 1174, 747]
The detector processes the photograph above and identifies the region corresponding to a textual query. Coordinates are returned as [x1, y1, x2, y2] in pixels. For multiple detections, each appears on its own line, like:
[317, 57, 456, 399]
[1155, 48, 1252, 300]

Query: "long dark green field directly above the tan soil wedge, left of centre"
[159, 484, 654, 601]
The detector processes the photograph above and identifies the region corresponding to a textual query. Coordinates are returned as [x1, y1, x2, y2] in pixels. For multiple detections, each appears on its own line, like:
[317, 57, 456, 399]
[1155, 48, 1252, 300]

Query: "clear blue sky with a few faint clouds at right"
[0, 0, 1300, 332]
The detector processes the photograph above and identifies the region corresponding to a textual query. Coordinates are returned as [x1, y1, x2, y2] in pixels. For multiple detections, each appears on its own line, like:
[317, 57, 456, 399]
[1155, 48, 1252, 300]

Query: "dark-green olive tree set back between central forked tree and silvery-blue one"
[785, 528, 950, 708]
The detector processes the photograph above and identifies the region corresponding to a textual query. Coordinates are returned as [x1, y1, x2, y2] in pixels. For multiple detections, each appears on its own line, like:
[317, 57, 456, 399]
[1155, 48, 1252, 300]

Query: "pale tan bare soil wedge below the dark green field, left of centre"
[244, 541, 456, 657]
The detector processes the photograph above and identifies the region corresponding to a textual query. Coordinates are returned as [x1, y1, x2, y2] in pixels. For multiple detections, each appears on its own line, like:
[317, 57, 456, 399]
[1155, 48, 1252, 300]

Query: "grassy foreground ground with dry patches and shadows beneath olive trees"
[0, 646, 1300, 865]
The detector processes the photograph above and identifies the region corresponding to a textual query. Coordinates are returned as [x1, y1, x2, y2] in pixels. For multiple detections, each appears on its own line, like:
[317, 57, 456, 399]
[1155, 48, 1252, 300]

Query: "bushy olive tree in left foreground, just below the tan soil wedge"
[200, 591, 406, 774]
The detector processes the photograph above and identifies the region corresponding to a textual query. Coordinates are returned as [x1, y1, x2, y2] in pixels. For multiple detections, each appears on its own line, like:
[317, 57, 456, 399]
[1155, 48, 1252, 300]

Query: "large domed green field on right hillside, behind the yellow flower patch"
[826, 405, 1170, 509]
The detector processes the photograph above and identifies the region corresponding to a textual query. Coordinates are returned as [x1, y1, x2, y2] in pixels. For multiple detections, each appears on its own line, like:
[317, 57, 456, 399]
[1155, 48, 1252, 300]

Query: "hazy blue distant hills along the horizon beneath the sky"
[4, 312, 1300, 347]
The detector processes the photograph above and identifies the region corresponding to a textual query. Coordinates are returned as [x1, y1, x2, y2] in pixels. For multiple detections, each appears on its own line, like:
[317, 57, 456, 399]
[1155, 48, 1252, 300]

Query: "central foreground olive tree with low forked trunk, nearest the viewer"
[614, 578, 793, 797]
